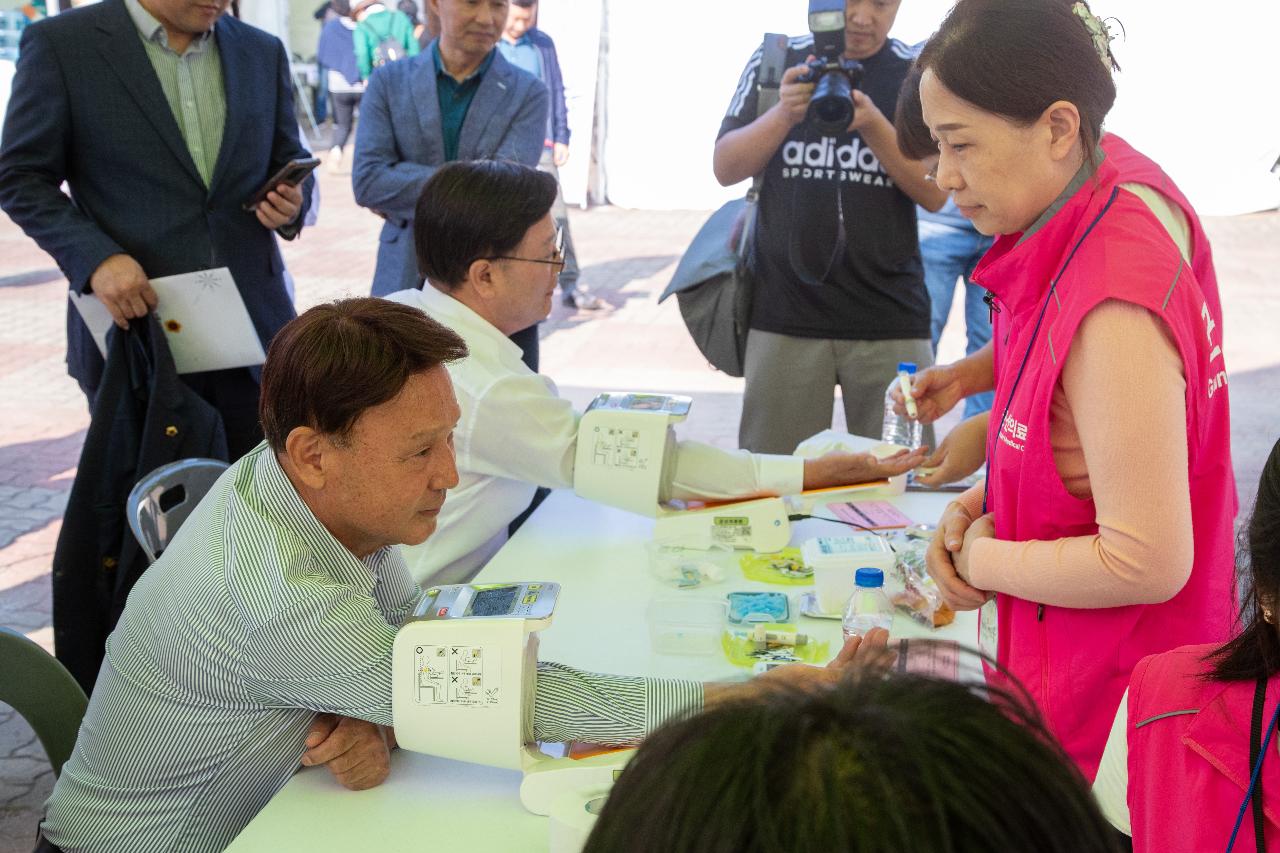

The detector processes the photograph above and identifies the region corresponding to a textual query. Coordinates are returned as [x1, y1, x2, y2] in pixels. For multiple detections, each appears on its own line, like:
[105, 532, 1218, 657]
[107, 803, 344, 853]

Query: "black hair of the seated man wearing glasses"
[413, 160, 556, 288]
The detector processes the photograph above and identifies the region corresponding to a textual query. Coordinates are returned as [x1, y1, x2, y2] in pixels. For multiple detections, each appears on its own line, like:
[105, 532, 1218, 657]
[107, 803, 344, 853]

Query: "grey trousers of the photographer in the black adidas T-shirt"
[737, 329, 933, 453]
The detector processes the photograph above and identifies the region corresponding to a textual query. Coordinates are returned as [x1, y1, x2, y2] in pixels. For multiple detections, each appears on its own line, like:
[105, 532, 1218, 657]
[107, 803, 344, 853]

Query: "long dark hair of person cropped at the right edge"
[1206, 442, 1280, 681]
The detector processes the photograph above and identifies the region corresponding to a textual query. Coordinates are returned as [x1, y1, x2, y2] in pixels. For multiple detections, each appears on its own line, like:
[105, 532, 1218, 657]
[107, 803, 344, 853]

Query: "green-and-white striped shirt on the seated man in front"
[42, 443, 701, 853]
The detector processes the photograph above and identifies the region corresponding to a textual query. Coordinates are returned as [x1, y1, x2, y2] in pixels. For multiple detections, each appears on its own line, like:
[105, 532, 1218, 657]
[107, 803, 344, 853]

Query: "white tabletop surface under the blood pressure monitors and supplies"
[228, 492, 977, 853]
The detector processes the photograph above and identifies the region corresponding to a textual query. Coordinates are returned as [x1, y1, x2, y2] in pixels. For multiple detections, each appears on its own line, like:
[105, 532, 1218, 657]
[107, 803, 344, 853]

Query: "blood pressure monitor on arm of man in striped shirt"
[392, 583, 631, 815]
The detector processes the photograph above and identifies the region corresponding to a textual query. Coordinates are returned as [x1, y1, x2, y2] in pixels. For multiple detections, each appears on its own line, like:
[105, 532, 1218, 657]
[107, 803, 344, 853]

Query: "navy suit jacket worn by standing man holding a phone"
[0, 0, 311, 388]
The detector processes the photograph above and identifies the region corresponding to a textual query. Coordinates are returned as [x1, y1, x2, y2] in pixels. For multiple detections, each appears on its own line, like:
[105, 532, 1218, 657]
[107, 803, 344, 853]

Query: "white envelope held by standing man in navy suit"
[70, 266, 266, 373]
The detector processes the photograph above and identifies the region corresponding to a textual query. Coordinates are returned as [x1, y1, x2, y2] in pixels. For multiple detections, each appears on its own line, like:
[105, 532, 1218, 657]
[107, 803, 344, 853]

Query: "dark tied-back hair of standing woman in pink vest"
[916, 0, 1116, 163]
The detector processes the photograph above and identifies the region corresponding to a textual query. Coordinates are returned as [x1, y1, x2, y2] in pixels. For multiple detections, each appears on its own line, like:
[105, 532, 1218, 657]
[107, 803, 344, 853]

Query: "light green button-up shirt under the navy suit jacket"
[124, 0, 227, 187]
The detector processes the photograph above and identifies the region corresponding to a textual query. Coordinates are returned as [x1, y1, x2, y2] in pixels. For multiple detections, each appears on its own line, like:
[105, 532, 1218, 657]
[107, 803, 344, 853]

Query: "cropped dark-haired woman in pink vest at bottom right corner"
[1093, 443, 1280, 853]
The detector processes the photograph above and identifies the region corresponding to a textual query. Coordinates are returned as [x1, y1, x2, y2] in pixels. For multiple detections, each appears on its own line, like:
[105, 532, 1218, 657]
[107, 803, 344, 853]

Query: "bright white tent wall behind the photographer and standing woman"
[540, 0, 1280, 215]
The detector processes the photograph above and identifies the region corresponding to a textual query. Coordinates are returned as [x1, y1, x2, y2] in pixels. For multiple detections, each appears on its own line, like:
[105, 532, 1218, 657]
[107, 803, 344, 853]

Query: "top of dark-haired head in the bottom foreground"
[584, 671, 1119, 853]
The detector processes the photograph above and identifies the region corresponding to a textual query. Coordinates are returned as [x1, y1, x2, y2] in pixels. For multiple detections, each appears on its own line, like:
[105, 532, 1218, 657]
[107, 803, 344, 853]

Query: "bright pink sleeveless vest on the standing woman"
[973, 144, 1236, 779]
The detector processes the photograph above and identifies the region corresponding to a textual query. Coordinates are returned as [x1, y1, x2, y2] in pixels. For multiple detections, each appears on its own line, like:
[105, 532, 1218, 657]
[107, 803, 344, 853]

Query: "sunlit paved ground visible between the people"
[0, 157, 1280, 853]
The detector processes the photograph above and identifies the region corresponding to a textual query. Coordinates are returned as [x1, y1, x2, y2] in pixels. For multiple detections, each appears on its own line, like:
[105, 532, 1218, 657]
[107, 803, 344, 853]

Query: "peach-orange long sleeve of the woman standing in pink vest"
[960, 301, 1193, 607]
